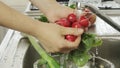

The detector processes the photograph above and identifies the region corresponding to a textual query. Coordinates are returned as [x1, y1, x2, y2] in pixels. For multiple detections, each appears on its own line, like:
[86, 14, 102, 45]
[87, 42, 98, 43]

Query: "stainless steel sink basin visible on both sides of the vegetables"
[23, 37, 120, 68]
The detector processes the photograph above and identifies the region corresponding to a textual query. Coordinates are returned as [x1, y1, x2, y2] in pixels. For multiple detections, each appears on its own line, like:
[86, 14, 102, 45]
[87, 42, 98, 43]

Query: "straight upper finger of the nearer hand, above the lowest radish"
[61, 27, 84, 36]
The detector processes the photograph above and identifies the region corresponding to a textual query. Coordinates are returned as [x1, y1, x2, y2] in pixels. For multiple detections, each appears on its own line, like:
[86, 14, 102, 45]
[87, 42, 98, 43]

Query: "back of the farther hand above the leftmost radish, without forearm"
[45, 4, 74, 23]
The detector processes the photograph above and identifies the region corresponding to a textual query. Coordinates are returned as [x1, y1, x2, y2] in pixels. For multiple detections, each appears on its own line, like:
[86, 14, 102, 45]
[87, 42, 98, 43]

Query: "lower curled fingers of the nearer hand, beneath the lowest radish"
[45, 36, 81, 53]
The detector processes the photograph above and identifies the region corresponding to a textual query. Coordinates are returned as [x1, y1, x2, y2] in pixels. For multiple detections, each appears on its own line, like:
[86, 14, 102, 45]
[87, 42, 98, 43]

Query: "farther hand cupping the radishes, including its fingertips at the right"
[44, 4, 96, 24]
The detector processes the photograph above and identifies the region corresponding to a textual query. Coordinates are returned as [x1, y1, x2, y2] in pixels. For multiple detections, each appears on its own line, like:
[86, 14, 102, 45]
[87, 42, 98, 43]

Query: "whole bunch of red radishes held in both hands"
[55, 9, 92, 42]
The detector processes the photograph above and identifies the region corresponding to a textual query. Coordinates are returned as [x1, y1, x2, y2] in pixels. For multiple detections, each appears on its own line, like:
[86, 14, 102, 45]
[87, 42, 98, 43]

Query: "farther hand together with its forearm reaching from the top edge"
[30, 0, 74, 22]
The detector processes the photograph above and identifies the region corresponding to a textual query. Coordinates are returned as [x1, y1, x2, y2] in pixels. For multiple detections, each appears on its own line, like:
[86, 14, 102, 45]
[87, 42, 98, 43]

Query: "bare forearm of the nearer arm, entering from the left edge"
[0, 2, 40, 34]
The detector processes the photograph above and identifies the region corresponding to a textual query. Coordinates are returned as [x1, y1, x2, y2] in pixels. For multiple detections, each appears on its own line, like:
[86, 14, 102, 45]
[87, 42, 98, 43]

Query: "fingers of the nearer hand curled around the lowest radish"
[60, 28, 84, 53]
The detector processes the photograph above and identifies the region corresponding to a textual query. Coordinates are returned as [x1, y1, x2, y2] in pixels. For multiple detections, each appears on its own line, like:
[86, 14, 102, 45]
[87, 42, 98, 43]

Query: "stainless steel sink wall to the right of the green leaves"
[92, 38, 120, 68]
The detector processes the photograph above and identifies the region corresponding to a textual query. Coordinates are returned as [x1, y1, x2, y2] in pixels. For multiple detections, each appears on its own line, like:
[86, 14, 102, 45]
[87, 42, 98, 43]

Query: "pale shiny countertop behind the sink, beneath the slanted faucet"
[88, 16, 120, 36]
